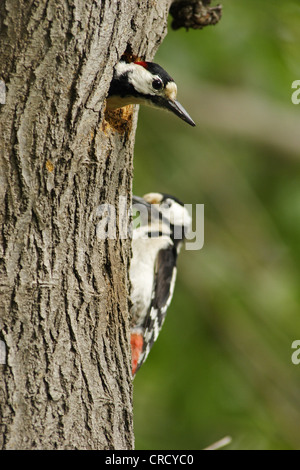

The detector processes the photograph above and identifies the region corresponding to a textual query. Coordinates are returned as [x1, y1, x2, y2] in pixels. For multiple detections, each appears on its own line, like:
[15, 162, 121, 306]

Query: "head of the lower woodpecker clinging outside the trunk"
[132, 193, 191, 245]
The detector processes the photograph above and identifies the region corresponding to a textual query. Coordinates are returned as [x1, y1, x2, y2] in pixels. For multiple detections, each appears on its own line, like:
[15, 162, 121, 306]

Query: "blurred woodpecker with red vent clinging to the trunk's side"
[130, 193, 191, 377]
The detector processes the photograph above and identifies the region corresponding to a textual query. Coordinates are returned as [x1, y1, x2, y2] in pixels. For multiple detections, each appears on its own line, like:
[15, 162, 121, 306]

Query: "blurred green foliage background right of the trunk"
[133, 0, 300, 450]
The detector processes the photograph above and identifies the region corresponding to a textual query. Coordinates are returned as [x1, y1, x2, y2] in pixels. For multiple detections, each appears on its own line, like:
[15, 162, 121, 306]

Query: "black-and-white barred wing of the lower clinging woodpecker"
[137, 245, 177, 370]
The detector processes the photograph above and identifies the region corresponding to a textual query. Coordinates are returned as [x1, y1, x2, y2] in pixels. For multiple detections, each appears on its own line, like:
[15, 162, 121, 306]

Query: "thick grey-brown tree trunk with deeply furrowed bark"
[0, 0, 170, 449]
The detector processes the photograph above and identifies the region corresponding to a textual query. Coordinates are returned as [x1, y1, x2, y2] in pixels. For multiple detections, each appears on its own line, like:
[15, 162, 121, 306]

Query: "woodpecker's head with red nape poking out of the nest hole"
[107, 60, 196, 126]
